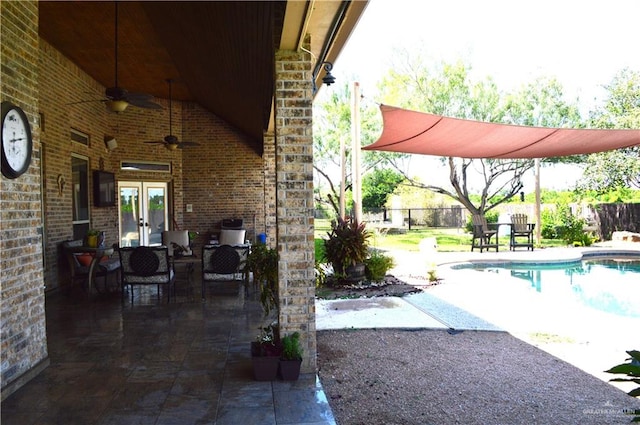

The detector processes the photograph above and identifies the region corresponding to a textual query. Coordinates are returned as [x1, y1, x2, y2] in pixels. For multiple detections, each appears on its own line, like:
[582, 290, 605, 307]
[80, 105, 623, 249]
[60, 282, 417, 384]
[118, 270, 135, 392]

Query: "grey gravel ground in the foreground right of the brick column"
[317, 329, 640, 425]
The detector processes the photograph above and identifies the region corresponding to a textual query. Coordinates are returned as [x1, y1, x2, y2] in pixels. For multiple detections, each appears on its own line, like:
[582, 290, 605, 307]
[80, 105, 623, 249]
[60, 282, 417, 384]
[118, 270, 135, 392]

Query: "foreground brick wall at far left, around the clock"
[0, 1, 47, 399]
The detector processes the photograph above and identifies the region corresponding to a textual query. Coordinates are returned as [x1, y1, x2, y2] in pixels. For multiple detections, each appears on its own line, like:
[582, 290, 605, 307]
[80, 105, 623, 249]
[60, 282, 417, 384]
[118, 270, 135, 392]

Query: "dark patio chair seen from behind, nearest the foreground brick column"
[202, 245, 249, 299]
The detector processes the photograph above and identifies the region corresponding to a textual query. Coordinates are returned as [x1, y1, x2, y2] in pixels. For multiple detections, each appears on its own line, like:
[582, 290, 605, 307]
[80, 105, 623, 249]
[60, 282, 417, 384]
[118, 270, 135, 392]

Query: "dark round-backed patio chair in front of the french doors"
[118, 246, 175, 304]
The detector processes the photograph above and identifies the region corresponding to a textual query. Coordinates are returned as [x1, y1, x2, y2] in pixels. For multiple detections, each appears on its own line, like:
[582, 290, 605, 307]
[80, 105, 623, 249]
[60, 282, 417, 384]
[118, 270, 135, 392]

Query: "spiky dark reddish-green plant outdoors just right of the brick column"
[324, 217, 371, 281]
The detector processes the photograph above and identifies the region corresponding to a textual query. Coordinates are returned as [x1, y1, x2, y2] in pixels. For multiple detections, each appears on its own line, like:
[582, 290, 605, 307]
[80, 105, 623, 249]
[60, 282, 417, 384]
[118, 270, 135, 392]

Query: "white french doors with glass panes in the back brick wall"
[118, 182, 169, 246]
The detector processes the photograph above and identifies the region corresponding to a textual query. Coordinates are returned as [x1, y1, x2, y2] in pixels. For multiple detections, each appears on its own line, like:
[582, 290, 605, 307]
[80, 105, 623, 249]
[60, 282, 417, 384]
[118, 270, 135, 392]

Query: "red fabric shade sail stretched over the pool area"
[363, 105, 640, 158]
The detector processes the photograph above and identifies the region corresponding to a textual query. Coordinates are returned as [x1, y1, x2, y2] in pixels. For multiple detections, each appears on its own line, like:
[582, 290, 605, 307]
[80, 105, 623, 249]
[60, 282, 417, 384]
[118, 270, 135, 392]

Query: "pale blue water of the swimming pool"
[452, 258, 640, 318]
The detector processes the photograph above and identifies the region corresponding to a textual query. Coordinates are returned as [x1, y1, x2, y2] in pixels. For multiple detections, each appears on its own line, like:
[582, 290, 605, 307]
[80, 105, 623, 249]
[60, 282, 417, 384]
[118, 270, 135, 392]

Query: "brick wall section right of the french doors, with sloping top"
[177, 104, 265, 247]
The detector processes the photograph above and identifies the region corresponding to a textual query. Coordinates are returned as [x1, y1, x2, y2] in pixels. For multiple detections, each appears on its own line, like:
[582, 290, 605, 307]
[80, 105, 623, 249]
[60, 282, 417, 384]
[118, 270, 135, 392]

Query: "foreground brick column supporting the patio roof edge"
[275, 40, 317, 373]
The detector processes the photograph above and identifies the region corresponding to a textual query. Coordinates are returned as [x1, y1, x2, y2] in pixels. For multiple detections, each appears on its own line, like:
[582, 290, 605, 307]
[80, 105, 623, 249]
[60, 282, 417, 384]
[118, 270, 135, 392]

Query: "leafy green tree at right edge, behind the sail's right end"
[578, 69, 640, 194]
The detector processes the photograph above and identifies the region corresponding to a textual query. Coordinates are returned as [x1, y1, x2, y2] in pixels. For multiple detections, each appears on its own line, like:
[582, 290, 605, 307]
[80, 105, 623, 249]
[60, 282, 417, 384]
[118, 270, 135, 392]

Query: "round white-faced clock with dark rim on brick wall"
[2, 102, 33, 179]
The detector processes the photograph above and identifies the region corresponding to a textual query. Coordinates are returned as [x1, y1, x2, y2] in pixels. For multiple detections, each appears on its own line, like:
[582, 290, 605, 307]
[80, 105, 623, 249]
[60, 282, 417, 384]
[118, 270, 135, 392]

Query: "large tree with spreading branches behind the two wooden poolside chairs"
[380, 55, 580, 214]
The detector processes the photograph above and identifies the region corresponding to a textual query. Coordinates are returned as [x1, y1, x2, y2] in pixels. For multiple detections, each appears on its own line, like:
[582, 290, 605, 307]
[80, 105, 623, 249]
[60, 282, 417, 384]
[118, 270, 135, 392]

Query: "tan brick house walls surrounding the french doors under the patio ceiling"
[40, 40, 273, 288]
